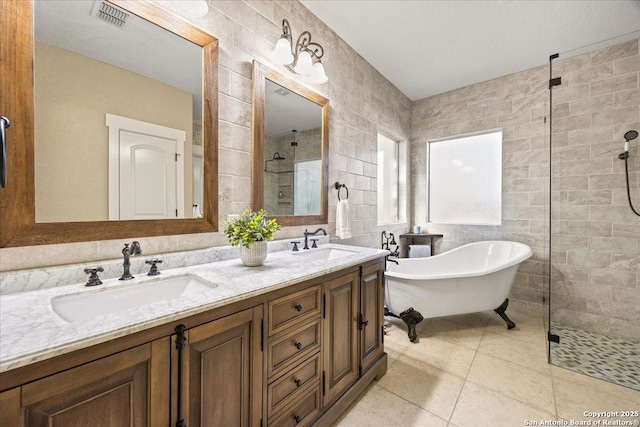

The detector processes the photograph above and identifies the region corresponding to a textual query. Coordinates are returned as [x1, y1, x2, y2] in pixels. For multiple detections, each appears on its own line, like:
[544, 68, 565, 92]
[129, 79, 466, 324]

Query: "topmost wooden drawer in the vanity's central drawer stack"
[269, 285, 322, 335]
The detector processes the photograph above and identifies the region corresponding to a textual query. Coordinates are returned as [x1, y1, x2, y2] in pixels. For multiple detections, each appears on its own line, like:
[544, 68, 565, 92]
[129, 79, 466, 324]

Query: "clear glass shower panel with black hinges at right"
[548, 32, 640, 390]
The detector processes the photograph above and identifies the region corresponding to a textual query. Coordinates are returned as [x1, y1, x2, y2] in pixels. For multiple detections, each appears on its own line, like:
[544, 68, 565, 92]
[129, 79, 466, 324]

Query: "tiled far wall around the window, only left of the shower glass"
[410, 59, 549, 314]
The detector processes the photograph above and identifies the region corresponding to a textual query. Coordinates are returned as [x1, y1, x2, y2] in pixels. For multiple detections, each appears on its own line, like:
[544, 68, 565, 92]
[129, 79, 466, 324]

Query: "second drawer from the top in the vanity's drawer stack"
[267, 317, 321, 378]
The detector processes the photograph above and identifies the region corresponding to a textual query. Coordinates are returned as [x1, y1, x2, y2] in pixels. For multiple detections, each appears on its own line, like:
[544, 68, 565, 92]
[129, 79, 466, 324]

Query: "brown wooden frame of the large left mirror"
[0, 0, 218, 247]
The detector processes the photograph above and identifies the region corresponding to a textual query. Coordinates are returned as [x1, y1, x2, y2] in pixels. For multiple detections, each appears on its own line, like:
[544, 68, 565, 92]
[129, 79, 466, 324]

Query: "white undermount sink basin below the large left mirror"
[51, 275, 216, 322]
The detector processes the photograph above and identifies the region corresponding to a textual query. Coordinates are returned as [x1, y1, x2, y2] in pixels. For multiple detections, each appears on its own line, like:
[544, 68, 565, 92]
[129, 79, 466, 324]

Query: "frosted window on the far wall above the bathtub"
[427, 130, 502, 225]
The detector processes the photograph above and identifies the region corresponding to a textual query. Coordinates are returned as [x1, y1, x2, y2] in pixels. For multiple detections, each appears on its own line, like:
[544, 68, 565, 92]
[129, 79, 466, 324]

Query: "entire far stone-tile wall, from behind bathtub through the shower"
[411, 40, 640, 340]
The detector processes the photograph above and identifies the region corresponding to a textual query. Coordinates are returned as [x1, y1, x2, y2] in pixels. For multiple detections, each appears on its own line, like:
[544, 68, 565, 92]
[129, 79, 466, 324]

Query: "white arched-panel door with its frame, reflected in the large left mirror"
[107, 114, 186, 220]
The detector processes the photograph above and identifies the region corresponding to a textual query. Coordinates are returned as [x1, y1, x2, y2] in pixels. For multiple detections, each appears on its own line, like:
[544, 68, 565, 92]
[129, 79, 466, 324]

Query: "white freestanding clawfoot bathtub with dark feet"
[385, 241, 533, 342]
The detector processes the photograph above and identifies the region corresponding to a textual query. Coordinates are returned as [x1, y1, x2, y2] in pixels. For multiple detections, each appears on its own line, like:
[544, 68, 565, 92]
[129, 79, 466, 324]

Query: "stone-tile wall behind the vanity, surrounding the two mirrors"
[0, 0, 411, 271]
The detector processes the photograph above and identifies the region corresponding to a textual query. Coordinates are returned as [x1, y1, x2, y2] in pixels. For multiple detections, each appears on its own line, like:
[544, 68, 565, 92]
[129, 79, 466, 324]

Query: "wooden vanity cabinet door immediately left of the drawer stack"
[178, 306, 262, 426]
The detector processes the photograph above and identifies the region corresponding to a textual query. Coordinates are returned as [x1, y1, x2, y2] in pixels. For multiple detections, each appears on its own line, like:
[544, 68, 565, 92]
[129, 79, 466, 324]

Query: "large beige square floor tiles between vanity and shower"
[335, 311, 640, 427]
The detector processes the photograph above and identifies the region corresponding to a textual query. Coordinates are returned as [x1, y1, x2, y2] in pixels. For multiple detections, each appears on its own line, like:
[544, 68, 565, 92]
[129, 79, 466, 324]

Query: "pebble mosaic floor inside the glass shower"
[550, 322, 640, 390]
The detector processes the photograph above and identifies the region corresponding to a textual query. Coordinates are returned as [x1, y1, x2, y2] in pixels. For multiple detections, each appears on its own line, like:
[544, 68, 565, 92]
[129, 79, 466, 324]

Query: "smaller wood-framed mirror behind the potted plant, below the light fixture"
[252, 61, 329, 225]
